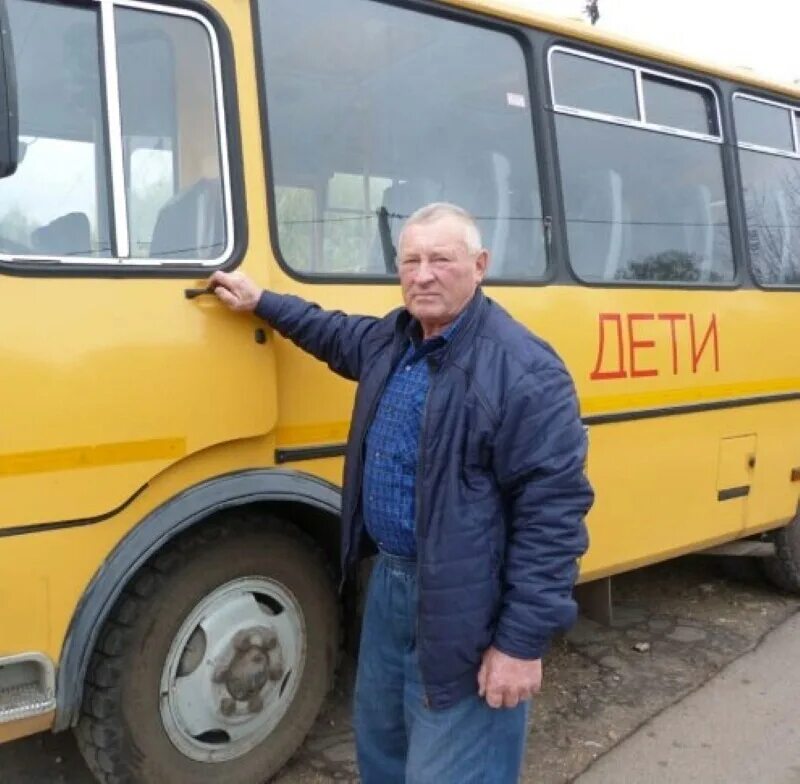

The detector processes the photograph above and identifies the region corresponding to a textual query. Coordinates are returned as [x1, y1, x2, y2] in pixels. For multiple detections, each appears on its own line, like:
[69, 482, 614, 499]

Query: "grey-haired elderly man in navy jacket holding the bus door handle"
[211, 204, 593, 784]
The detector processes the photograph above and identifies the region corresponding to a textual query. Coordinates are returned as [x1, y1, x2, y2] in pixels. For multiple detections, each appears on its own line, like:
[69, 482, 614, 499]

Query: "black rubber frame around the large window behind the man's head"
[250, 0, 560, 288]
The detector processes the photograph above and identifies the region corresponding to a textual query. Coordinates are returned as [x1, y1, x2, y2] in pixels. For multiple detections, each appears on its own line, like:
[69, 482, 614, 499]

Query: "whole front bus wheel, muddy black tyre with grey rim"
[76, 519, 339, 784]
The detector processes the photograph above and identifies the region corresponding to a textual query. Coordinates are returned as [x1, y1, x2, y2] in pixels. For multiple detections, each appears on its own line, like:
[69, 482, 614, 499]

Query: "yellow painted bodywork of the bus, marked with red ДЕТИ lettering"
[0, 0, 800, 760]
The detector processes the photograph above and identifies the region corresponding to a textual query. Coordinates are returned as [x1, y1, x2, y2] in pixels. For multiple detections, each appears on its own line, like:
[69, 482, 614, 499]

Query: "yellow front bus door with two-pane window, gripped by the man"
[0, 0, 276, 532]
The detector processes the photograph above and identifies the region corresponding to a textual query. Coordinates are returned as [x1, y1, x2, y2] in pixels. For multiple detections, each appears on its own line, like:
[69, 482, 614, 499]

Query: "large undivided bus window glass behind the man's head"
[259, 0, 546, 279]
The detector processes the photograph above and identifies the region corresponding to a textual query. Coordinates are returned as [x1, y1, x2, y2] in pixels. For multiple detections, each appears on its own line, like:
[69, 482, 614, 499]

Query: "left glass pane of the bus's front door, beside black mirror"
[0, 0, 111, 258]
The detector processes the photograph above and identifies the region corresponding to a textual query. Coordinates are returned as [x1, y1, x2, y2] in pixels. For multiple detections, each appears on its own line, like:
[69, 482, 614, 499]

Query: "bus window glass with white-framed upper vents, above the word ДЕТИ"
[551, 50, 734, 283]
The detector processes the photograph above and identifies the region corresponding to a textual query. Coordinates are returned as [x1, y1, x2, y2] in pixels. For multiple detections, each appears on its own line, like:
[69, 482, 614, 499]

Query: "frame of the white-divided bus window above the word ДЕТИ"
[543, 43, 740, 291]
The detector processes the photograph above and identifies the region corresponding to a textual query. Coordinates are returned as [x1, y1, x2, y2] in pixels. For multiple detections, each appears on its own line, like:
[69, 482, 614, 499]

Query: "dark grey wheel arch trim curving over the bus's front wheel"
[53, 469, 341, 732]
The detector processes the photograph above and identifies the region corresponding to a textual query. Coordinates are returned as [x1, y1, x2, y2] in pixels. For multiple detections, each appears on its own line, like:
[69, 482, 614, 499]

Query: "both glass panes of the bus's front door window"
[0, 0, 232, 263]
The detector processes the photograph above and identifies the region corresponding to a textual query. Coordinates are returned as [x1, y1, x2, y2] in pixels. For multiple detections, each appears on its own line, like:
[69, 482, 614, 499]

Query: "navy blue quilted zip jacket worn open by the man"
[256, 290, 593, 708]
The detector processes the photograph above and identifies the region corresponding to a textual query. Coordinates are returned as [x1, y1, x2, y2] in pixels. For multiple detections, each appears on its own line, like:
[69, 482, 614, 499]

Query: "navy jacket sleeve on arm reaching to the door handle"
[255, 291, 380, 381]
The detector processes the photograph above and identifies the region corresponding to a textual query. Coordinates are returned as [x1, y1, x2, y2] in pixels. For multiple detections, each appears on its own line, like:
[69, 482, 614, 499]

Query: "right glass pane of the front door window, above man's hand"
[115, 8, 227, 260]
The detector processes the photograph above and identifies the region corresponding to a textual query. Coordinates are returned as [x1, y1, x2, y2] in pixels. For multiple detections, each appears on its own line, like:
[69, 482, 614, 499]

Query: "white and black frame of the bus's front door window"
[0, 0, 248, 278]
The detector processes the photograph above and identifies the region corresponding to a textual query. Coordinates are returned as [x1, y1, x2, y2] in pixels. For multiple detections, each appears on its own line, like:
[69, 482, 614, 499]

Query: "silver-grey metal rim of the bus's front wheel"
[160, 577, 307, 762]
